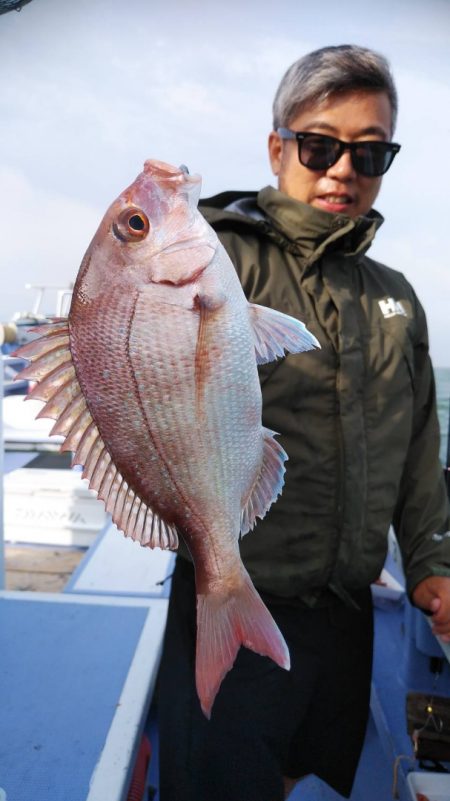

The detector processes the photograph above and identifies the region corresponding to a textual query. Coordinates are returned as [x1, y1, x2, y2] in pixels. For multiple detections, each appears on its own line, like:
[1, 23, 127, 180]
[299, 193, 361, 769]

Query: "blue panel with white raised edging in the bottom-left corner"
[0, 592, 167, 801]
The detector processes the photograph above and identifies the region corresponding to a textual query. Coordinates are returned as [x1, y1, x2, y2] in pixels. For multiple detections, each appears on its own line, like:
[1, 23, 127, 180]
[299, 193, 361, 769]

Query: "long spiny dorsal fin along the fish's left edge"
[15, 320, 178, 550]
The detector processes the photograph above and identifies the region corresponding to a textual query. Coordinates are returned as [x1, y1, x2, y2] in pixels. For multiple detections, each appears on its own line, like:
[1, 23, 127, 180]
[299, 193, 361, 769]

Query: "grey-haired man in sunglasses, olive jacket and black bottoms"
[160, 46, 450, 801]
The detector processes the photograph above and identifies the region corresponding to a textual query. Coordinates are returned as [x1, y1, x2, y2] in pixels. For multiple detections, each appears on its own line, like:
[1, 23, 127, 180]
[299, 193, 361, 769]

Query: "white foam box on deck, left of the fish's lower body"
[4, 467, 107, 547]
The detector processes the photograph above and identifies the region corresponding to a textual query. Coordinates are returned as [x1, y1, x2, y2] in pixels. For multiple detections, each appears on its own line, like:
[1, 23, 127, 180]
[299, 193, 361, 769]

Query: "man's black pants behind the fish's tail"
[158, 558, 373, 801]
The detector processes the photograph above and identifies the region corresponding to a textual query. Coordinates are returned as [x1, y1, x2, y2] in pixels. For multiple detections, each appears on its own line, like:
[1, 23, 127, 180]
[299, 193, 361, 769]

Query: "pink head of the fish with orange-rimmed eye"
[74, 160, 217, 302]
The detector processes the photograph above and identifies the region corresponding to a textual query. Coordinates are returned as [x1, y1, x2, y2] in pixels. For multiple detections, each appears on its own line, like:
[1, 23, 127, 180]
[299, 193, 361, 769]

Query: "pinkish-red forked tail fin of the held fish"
[196, 571, 290, 718]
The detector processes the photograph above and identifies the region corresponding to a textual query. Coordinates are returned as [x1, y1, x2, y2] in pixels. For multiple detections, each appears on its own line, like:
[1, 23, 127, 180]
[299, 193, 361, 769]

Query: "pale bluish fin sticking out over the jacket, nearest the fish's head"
[249, 303, 320, 364]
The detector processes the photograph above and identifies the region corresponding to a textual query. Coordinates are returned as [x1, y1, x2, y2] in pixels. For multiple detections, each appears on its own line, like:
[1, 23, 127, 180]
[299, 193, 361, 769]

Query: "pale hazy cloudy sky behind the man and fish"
[0, 0, 450, 366]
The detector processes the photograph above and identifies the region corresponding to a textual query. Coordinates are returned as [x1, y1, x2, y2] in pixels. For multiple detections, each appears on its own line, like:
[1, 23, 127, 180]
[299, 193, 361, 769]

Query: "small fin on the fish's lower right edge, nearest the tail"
[241, 427, 288, 536]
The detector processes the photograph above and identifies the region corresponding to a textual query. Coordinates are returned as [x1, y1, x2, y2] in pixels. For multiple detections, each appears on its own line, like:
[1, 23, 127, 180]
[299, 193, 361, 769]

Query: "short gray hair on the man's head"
[273, 45, 398, 133]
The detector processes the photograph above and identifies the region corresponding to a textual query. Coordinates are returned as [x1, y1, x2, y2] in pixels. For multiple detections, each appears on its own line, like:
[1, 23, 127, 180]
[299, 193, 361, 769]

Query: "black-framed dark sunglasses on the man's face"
[277, 128, 401, 178]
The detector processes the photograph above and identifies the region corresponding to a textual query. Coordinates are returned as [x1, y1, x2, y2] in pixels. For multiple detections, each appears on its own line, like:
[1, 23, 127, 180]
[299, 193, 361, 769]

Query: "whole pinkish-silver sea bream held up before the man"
[17, 160, 320, 718]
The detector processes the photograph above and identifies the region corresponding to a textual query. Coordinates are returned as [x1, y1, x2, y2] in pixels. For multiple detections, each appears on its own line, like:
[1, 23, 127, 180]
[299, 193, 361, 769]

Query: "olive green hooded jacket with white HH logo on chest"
[200, 187, 450, 606]
